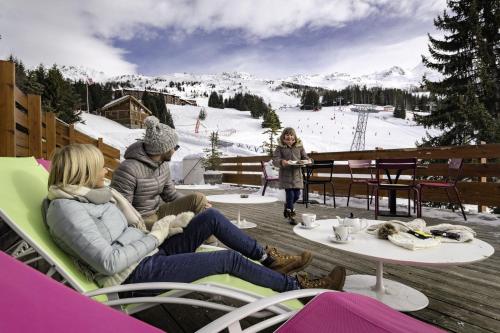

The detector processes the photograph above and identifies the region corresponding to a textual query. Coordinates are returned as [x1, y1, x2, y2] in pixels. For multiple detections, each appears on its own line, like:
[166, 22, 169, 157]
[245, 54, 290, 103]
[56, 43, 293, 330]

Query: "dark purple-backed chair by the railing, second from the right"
[370, 158, 421, 219]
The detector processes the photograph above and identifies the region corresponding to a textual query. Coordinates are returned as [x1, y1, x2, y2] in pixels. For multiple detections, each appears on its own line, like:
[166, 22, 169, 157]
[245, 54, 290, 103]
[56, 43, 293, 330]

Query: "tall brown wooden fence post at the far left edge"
[0, 61, 16, 157]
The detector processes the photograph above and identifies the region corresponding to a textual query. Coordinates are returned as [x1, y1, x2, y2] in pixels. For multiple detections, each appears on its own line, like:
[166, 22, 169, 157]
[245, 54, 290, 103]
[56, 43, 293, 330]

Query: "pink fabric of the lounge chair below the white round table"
[276, 292, 443, 333]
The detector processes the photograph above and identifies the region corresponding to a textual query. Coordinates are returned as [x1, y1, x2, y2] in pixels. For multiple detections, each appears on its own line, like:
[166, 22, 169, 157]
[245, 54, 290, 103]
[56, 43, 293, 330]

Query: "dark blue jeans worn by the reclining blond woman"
[124, 208, 299, 292]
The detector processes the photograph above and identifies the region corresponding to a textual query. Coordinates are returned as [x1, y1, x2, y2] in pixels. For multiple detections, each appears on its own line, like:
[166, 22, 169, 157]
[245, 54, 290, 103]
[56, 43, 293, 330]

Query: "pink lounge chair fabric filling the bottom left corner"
[0, 251, 162, 333]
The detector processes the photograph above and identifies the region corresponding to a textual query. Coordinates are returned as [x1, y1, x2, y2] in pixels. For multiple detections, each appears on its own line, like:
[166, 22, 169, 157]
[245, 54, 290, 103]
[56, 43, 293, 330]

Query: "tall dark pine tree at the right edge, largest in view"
[416, 0, 500, 145]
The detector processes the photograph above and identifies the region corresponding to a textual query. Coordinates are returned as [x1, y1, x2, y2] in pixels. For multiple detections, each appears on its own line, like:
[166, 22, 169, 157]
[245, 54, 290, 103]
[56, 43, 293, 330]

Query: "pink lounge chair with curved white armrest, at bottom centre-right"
[197, 289, 444, 333]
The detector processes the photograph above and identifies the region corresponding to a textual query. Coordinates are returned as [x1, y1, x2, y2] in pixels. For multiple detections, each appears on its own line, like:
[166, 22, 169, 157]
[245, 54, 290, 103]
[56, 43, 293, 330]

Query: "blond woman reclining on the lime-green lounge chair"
[46, 144, 345, 292]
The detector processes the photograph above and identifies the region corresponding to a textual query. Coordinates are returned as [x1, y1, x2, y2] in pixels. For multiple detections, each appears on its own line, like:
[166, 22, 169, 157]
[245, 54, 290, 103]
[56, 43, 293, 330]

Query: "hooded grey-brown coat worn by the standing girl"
[273, 139, 309, 189]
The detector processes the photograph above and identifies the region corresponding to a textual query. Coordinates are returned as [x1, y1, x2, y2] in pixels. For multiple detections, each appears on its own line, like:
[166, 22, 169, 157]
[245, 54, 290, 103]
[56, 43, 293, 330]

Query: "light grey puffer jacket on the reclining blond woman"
[46, 199, 158, 287]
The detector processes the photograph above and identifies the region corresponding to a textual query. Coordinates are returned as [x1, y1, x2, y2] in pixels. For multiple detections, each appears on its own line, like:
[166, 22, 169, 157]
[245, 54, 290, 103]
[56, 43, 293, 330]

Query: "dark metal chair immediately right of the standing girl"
[302, 160, 337, 208]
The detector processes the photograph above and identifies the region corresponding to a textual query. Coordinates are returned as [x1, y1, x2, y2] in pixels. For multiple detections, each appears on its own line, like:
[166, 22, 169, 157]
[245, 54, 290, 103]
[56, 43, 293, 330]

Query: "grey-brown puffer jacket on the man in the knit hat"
[111, 141, 182, 217]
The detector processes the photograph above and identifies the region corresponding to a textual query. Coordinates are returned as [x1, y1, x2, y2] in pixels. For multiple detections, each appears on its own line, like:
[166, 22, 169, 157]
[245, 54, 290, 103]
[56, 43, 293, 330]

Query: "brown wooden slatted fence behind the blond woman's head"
[0, 61, 120, 170]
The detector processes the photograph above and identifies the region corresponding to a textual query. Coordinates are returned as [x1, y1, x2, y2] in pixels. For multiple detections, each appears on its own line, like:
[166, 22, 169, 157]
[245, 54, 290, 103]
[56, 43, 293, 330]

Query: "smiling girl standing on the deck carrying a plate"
[273, 127, 310, 225]
